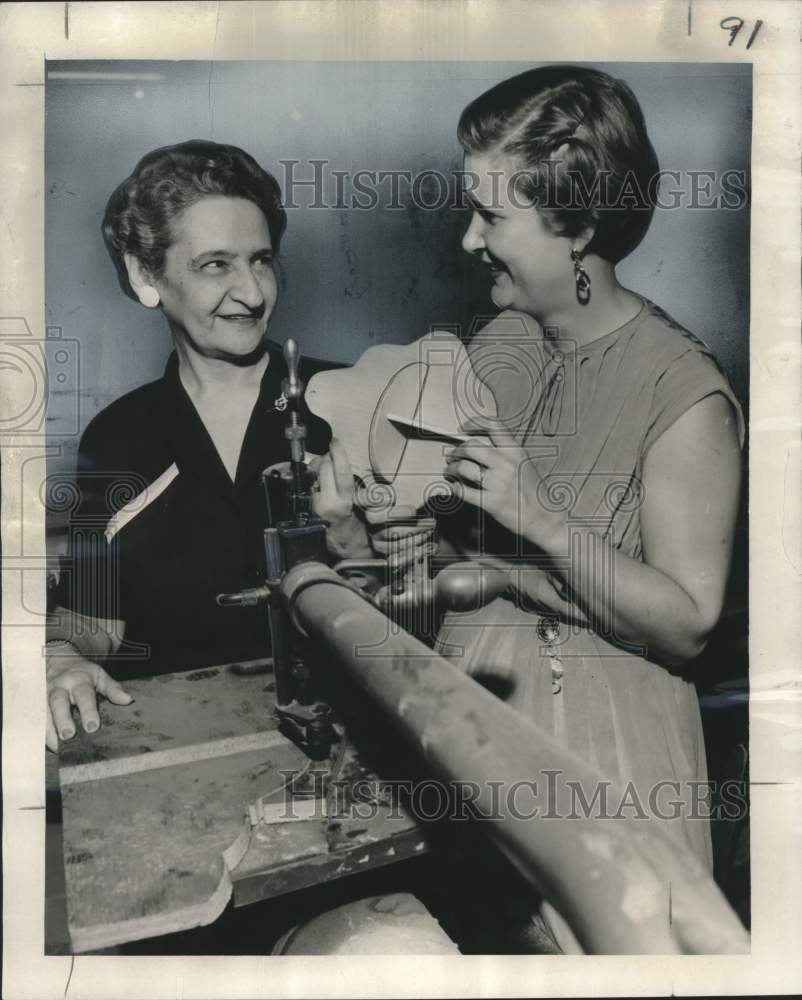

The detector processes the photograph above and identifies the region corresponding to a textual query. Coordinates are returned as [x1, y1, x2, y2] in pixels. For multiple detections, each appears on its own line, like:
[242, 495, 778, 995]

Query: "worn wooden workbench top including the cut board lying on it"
[54, 665, 426, 952]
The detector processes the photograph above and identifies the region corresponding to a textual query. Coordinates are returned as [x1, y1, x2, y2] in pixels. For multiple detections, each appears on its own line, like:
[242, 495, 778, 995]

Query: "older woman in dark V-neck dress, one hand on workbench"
[47, 141, 364, 749]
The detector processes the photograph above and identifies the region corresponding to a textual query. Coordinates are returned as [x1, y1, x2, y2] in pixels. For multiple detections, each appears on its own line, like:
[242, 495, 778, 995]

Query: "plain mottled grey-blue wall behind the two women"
[45, 61, 752, 473]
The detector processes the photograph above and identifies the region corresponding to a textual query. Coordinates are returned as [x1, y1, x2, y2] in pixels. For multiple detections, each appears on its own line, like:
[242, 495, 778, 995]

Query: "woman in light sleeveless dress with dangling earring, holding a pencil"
[440, 66, 743, 884]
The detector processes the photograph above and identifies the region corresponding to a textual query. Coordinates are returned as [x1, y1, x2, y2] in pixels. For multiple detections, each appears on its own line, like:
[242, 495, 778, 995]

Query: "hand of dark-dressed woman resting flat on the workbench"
[46, 643, 134, 753]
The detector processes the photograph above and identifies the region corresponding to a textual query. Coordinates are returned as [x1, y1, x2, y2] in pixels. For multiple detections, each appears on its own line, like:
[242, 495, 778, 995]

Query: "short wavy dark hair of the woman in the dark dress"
[103, 139, 287, 299]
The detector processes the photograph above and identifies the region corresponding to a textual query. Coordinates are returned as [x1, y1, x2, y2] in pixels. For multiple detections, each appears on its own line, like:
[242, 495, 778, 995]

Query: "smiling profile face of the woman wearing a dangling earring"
[462, 153, 586, 319]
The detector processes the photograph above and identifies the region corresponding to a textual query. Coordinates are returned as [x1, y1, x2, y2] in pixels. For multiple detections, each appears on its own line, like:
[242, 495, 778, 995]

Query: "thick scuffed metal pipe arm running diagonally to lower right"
[281, 563, 749, 954]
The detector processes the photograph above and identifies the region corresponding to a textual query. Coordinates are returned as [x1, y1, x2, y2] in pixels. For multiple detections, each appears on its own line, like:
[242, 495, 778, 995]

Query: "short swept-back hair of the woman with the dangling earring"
[458, 66, 659, 263]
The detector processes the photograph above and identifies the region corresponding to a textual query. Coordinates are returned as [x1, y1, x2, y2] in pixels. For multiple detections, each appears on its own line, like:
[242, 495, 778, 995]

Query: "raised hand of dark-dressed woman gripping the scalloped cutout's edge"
[309, 438, 371, 559]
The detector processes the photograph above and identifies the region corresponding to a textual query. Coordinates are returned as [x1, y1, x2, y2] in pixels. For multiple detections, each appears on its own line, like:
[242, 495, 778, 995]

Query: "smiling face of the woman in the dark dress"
[153, 196, 277, 361]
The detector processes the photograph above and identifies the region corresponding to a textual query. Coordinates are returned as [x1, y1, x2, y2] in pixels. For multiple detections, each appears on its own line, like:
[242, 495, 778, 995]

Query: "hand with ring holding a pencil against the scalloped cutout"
[445, 420, 565, 547]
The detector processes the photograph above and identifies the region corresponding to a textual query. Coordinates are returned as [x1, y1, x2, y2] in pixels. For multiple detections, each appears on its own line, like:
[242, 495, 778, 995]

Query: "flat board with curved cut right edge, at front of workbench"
[63, 744, 306, 951]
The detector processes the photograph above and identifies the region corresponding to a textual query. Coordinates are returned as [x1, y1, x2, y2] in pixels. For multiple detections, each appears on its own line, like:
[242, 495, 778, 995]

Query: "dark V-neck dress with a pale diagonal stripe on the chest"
[57, 344, 330, 679]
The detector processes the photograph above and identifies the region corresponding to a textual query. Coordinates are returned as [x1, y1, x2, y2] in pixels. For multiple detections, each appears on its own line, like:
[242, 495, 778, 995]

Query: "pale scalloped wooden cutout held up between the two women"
[305, 330, 498, 509]
